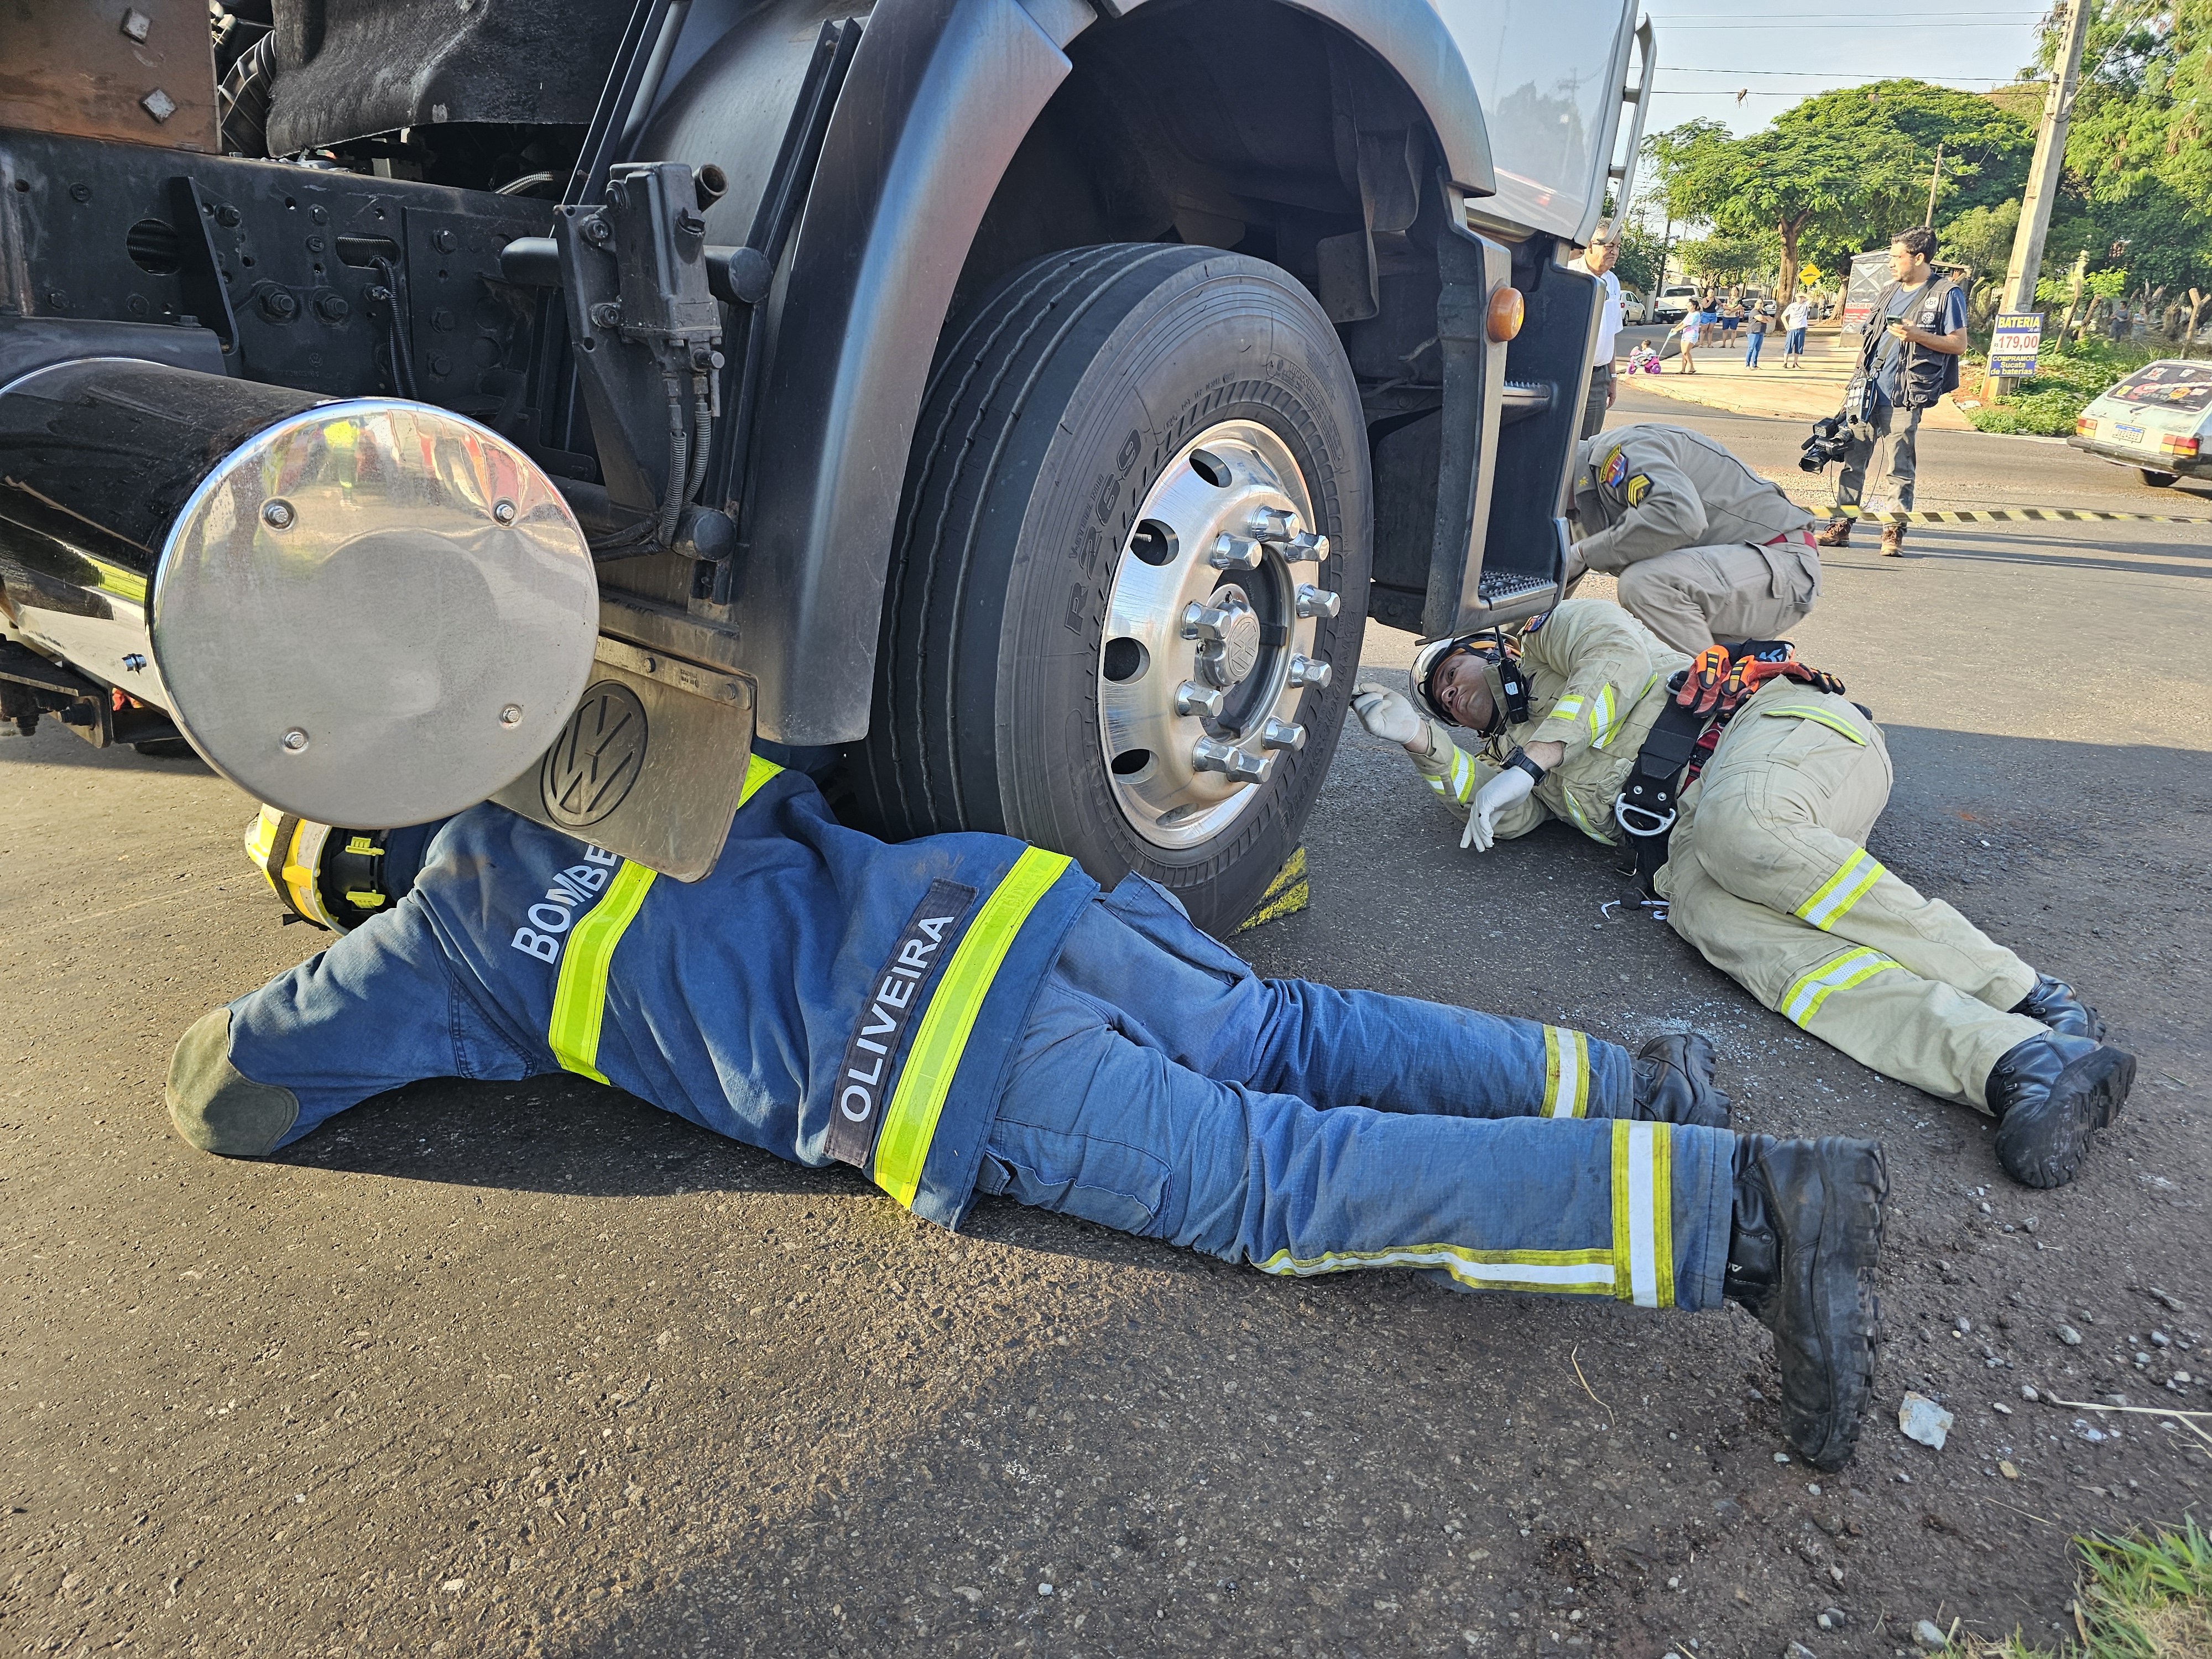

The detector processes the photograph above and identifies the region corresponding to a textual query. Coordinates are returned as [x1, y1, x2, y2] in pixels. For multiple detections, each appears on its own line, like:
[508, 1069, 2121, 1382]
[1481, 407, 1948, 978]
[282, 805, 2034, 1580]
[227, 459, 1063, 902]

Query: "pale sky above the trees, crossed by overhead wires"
[1639, 0, 2048, 215]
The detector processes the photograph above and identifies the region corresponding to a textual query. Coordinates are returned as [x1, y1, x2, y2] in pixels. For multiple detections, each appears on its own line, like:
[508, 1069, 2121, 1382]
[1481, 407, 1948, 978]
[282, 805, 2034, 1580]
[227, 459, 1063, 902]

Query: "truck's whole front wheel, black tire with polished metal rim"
[854, 243, 1371, 933]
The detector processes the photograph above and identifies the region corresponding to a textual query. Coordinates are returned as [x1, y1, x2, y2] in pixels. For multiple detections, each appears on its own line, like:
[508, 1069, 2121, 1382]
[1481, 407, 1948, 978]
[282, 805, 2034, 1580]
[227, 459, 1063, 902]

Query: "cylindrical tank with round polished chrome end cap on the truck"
[0, 358, 599, 830]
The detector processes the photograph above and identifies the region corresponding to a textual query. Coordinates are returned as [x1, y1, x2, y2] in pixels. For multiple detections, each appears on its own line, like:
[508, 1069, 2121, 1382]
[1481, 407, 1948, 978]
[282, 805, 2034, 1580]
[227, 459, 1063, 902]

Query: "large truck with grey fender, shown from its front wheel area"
[0, 0, 1655, 931]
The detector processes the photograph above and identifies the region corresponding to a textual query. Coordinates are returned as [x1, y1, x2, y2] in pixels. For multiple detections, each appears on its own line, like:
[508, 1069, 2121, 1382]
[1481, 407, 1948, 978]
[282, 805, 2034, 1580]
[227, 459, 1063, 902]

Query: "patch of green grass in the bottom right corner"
[1949, 1515, 2212, 1659]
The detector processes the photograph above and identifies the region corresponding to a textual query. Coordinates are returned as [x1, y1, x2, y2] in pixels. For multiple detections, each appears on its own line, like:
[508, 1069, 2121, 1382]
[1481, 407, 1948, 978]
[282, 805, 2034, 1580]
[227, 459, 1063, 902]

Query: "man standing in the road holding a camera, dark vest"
[1801, 226, 1966, 553]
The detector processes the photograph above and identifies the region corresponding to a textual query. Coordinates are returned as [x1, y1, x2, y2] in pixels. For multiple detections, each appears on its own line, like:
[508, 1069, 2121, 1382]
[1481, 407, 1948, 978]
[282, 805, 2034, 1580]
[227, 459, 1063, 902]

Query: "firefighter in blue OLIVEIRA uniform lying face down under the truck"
[168, 759, 1887, 1467]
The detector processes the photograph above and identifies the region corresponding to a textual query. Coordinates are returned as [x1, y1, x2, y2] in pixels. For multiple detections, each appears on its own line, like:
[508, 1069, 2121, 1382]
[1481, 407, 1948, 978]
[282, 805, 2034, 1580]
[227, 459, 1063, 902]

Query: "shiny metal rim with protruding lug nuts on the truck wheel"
[1099, 420, 1340, 849]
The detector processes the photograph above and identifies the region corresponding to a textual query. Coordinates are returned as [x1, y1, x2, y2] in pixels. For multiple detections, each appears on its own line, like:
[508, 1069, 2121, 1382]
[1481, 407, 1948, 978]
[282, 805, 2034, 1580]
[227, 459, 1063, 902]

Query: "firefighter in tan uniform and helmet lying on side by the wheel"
[1354, 602, 2135, 1186]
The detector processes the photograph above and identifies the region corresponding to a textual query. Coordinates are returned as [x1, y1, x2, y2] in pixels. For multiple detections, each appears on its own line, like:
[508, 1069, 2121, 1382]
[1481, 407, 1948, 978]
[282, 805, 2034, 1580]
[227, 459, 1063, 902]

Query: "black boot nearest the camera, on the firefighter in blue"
[1723, 1135, 1889, 1469]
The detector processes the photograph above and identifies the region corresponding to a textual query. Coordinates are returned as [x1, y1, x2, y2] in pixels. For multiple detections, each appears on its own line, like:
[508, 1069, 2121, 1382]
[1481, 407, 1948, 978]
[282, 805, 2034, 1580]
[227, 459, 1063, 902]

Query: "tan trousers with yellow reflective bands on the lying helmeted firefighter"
[1657, 688, 2044, 1110]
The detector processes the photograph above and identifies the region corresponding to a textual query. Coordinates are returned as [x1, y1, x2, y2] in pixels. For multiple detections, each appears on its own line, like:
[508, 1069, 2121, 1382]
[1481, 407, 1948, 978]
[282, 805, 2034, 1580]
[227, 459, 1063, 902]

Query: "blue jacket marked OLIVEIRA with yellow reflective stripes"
[230, 759, 1097, 1225]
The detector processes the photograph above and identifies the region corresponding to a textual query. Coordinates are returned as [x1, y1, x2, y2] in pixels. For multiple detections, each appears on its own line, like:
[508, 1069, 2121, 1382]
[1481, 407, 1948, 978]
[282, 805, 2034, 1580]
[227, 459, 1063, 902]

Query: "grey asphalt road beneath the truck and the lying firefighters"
[0, 392, 2212, 1659]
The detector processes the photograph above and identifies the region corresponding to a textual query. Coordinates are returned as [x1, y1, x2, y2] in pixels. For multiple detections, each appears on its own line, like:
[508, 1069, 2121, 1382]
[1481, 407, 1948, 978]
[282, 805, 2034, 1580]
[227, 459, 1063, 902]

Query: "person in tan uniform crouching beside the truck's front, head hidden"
[1571, 425, 1820, 655]
